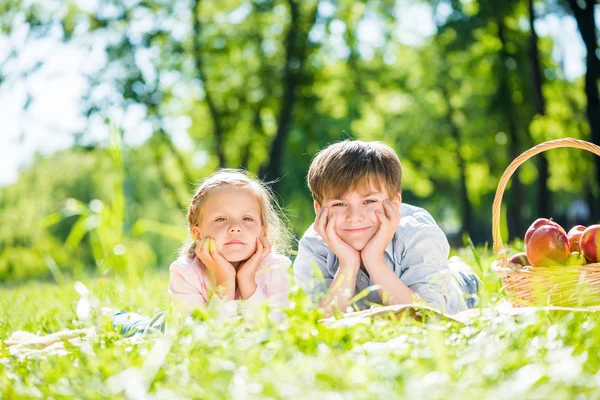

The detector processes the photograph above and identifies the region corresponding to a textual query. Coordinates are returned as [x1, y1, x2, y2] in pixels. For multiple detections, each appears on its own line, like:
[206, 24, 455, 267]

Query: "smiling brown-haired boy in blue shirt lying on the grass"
[294, 140, 478, 314]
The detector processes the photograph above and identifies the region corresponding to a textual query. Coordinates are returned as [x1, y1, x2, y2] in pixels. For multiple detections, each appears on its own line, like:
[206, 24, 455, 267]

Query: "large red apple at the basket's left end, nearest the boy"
[527, 225, 571, 267]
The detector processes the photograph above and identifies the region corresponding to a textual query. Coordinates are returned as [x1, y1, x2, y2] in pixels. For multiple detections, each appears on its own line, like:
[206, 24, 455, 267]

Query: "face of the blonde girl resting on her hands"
[192, 186, 265, 263]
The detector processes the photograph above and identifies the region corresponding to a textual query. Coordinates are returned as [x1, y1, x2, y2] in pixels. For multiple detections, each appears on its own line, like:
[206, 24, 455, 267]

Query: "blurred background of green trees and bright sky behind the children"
[0, 0, 600, 282]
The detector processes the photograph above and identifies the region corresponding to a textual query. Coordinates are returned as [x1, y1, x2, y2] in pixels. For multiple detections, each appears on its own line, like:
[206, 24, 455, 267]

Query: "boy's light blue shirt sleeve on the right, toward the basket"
[400, 225, 467, 314]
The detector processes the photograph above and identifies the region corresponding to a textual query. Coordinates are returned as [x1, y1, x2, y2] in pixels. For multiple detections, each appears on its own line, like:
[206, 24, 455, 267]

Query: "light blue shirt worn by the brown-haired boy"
[294, 203, 467, 314]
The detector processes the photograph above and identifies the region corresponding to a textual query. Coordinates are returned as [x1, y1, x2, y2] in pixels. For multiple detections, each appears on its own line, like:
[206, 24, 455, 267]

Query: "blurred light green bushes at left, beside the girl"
[0, 139, 185, 281]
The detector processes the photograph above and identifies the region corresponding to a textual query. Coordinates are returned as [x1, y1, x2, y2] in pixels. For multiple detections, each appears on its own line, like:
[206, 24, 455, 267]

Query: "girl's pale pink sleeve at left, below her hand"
[169, 261, 207, 309]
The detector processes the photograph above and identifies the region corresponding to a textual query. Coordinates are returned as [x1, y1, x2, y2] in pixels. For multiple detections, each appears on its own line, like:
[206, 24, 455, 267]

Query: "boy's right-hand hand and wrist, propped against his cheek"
[360, 200, 400, 271]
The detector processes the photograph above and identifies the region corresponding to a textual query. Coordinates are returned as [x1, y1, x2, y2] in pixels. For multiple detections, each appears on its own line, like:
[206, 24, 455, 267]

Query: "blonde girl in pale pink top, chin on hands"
[169, 169, 291, 312]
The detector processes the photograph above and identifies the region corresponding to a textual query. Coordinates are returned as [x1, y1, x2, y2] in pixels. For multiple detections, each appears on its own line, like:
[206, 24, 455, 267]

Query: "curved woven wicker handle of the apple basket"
[492, 138, 600, 266]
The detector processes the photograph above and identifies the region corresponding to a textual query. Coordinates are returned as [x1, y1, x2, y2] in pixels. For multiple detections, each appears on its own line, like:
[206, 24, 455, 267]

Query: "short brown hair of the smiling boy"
[308, 139, 402, 205]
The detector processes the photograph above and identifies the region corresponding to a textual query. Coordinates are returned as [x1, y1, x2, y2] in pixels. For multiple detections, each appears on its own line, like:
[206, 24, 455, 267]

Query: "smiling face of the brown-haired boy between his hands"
[315, 184, 401, 251]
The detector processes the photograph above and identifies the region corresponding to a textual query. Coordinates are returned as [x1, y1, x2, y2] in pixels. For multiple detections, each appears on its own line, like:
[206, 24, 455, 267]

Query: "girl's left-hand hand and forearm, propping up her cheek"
[194, 236, 235, 300]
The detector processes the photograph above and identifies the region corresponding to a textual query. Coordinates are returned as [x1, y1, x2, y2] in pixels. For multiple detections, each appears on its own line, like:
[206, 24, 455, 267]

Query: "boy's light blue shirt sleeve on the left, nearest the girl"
[294, 236, 333, 300]
